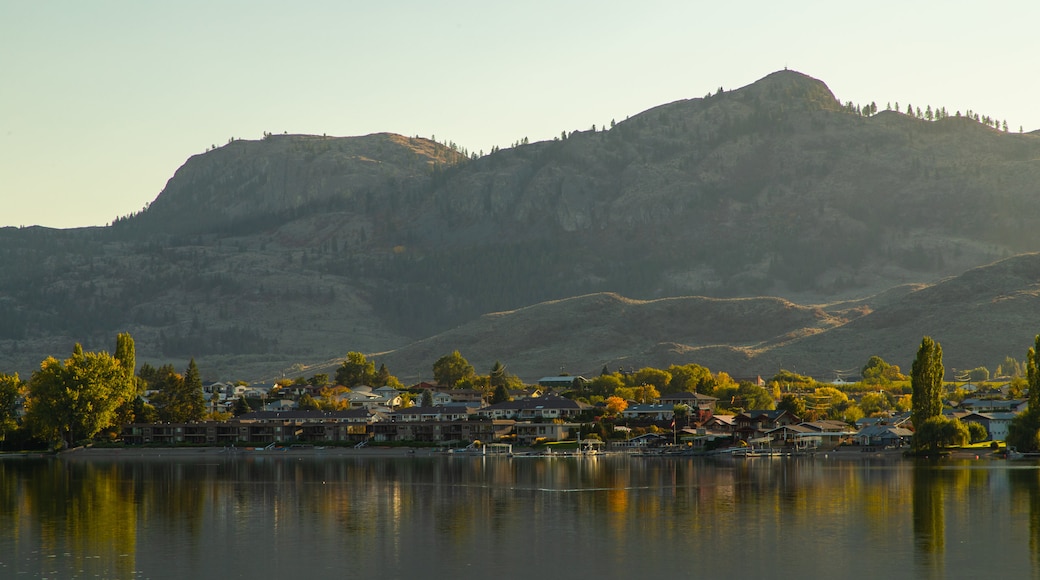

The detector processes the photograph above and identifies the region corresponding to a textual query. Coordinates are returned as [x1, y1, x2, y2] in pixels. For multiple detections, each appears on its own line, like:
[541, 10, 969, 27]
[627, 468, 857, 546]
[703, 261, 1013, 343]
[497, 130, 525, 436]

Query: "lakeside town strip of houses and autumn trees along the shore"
[0, 335, 1040, 454]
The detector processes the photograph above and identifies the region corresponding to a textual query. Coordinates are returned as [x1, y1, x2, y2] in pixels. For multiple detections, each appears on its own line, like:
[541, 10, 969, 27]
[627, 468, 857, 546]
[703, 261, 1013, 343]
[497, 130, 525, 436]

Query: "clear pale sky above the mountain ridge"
[0, 0, 1040, 228]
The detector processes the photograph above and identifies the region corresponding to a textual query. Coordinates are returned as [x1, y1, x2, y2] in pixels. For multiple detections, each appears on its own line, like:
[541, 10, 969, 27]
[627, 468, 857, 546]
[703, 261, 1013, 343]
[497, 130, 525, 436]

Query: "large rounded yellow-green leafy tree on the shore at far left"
[27, 344, 135, 446]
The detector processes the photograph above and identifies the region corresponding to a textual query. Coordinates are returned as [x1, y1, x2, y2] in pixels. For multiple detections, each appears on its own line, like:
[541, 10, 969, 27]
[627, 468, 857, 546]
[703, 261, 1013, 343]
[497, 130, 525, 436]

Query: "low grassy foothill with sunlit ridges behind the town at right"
[375, 254, 1040, 380]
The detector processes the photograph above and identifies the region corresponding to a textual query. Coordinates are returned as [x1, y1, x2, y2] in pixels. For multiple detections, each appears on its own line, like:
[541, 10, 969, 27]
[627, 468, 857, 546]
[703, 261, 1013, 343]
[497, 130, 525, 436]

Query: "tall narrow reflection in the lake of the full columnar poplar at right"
[912, 464, 946, 578]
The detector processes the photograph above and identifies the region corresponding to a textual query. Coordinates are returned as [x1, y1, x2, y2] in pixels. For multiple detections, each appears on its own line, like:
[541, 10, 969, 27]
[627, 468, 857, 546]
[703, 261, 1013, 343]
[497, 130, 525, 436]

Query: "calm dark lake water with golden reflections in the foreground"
[0, 455, 1040, 579]
